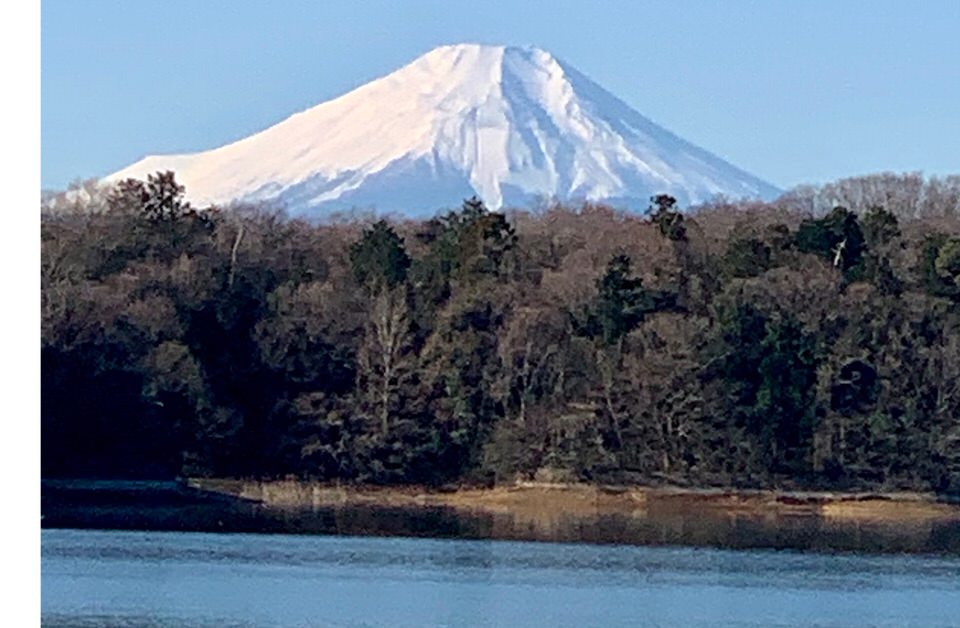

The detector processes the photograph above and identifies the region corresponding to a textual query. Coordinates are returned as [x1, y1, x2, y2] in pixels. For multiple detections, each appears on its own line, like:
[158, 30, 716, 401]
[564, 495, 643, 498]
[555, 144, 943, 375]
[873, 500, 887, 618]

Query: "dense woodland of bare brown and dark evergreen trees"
[41, 173, 960, 494]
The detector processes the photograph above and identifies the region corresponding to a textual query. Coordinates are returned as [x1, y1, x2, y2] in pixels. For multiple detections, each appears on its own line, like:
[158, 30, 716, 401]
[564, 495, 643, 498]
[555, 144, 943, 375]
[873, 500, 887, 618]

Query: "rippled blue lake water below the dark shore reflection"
[41, 529, 960, 628]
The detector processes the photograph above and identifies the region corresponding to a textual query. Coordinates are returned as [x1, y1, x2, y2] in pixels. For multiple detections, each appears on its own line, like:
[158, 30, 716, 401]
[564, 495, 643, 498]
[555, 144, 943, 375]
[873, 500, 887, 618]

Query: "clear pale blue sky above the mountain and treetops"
[41, 0, 960, 188]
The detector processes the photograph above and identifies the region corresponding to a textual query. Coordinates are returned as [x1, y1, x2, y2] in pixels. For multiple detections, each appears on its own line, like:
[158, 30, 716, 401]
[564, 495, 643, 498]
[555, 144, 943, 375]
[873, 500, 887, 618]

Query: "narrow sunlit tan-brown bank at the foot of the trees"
[188, 478, 960, 525]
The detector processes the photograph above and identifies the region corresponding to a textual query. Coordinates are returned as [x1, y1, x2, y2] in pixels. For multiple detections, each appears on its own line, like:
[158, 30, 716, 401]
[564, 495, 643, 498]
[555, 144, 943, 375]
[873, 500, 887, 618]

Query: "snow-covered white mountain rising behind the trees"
[105, 44, 778, 216]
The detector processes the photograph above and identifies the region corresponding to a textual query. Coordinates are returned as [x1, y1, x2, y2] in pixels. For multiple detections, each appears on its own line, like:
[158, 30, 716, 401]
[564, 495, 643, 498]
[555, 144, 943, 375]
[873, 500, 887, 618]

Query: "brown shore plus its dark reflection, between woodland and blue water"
[41, 479, 960, 556]
